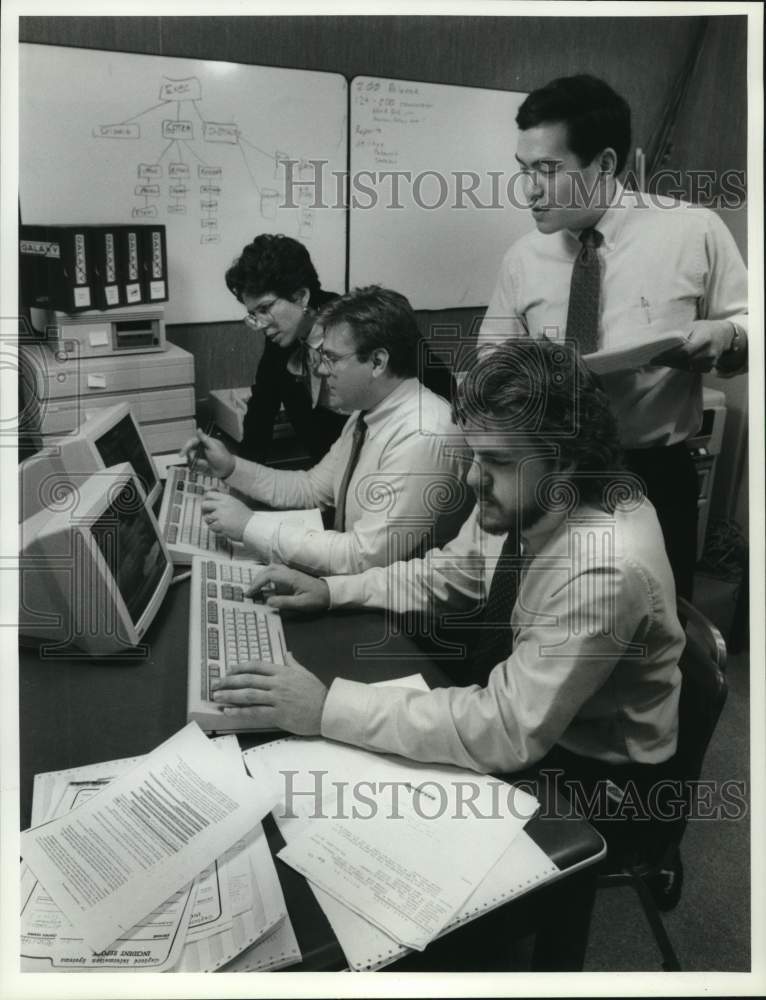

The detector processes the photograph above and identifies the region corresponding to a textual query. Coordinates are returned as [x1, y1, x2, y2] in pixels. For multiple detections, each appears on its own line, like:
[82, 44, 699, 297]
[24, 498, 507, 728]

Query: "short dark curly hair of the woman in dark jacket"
[226, 233, 320, 307]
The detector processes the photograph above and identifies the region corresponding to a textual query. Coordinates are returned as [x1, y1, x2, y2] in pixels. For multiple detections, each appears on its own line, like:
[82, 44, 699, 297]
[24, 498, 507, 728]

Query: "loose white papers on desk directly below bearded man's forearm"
[243, 682, 560, 970]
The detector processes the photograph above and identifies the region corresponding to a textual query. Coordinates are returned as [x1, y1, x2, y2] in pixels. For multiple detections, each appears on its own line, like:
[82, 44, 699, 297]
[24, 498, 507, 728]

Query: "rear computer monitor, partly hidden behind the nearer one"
[19, 403, 162, 521]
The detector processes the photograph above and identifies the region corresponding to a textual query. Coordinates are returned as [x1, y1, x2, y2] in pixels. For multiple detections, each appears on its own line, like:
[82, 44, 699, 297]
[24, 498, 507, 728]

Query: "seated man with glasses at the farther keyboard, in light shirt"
[182, 286, 467, 574]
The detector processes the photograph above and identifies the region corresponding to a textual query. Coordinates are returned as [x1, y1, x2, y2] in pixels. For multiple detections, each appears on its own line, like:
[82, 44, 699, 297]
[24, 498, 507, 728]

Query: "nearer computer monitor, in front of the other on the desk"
[19, 463, 173, 658]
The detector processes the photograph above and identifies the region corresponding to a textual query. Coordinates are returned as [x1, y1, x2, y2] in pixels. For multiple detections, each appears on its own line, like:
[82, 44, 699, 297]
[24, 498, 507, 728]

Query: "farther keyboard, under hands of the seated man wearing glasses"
[158, 465, 235, 564]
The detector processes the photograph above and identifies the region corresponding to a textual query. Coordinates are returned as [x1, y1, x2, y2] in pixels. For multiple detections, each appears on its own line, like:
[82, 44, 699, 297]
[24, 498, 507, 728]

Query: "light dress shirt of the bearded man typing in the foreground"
[322, 500, 684, 772]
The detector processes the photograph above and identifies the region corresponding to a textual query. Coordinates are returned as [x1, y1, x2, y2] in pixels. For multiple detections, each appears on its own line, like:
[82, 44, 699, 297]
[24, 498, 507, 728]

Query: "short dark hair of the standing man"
[516, 73, 630, 174]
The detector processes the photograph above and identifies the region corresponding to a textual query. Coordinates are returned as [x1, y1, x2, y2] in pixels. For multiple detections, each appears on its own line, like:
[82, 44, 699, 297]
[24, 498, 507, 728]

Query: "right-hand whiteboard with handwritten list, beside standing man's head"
[349, 76, 534, 309]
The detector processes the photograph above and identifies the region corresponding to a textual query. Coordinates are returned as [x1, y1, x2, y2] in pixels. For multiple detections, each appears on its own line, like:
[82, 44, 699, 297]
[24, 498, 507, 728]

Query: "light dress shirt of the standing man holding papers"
[478, 184, 747, 448]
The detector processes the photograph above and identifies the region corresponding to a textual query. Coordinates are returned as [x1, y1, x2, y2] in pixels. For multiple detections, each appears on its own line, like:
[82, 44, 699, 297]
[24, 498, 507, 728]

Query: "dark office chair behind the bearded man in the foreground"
[597, 598, 728, 972]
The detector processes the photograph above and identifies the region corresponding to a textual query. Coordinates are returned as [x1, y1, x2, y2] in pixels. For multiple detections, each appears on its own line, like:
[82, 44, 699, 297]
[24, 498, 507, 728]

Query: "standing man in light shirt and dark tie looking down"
[478, 76, 747, 597]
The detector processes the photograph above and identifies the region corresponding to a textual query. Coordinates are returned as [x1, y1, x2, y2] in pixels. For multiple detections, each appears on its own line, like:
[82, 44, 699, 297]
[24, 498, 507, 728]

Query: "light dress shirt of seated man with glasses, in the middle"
[227, 378, 465, 573]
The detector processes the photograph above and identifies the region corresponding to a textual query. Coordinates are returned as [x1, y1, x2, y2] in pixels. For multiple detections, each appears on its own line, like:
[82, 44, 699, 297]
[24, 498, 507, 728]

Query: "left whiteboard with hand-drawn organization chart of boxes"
[19, 44, 348, 323]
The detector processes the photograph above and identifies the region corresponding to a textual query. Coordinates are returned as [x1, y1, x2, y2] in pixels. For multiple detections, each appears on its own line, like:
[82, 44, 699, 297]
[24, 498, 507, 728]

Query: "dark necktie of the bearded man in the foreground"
[471, 532, 529, 685]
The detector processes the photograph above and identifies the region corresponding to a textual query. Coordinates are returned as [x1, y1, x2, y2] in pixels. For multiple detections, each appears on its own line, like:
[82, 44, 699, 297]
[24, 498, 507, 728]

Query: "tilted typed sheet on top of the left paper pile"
[21, 723, 275, 952]
